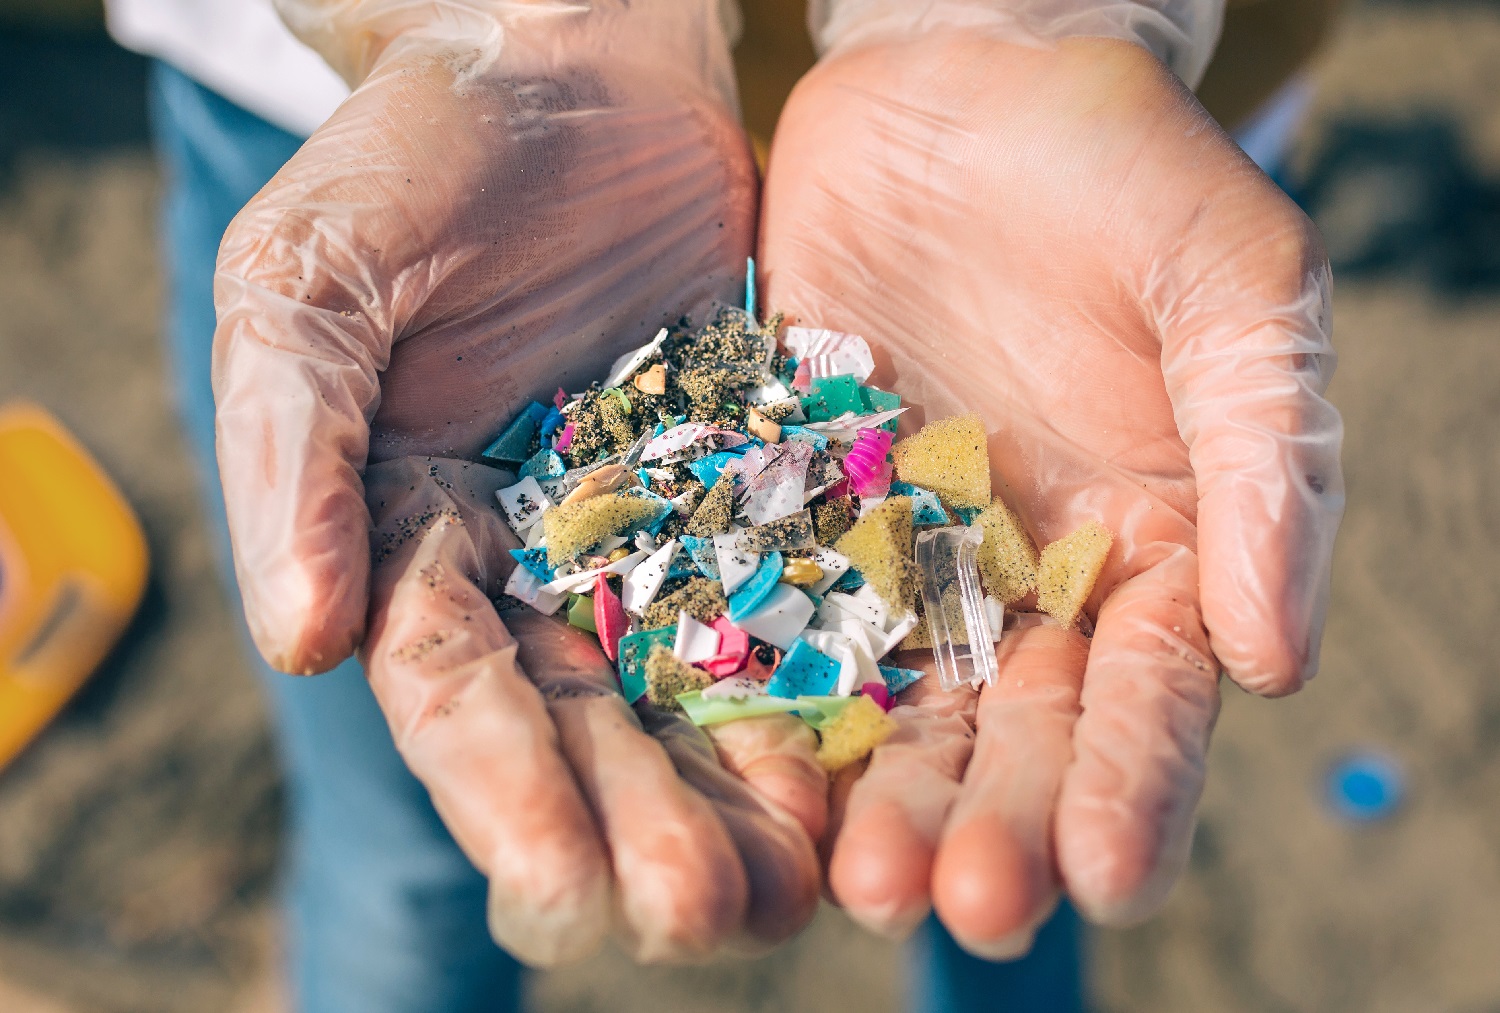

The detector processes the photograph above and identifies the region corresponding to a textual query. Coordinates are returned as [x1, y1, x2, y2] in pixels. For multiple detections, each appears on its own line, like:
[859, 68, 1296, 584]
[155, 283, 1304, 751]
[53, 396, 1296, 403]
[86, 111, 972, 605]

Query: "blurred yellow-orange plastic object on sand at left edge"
[0, 404, 147, 768]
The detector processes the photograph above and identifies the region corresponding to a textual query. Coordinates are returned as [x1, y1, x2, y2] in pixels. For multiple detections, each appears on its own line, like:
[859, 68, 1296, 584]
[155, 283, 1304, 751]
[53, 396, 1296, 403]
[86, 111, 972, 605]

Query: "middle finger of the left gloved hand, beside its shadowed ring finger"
[510, 611, 749, 962]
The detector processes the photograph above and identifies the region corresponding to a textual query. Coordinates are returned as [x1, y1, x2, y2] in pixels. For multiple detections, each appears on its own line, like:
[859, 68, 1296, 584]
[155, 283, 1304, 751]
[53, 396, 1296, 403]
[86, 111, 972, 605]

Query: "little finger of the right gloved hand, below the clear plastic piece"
[828, 675, 977, 938]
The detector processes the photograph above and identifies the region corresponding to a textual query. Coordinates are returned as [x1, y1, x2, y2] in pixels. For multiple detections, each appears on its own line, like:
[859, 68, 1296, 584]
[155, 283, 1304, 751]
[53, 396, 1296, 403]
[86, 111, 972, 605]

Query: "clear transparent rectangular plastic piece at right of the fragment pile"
[917, 527, 998, 690]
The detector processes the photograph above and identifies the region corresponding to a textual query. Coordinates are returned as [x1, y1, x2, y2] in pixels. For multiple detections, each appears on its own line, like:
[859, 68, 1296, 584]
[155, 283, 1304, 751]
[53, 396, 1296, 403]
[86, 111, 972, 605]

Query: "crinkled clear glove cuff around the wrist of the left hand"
[275, 0, 740, 107]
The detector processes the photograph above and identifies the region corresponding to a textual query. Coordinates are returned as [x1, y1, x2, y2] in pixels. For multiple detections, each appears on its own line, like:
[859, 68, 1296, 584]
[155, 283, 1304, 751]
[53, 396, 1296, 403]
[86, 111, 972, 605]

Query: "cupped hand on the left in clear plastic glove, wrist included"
[215, 0, 827, 963]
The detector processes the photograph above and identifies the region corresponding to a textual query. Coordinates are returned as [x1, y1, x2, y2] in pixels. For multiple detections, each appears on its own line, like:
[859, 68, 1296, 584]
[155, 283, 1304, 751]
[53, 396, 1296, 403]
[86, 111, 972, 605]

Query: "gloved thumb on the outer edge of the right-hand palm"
[1158, 180, 1344, 696]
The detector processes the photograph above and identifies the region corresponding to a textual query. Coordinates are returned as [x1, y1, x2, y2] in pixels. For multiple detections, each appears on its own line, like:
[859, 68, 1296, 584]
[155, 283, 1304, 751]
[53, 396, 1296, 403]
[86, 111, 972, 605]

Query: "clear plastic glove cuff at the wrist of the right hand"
[807, 0, 1224, 87]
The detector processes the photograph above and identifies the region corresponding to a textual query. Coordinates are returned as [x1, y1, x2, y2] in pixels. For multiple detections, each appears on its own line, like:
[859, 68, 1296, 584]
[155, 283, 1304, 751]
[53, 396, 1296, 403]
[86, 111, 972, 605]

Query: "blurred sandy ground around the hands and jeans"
[0, 0, 1500, 1013]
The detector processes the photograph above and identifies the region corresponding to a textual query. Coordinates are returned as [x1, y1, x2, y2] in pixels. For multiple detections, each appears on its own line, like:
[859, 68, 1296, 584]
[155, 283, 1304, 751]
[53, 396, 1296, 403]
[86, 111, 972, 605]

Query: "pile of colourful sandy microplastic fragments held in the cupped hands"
[485, 285, 1113, 771]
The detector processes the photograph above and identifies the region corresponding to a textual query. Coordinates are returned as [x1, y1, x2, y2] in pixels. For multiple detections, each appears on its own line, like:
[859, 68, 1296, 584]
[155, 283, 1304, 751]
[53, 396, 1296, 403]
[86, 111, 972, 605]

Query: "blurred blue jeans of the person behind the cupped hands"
[150, 63, 1082, 1013]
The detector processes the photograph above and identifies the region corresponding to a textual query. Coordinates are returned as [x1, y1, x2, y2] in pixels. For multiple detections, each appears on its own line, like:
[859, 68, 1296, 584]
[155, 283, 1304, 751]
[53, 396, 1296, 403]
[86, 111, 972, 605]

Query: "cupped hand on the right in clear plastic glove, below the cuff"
[761, 30, 1343, 956]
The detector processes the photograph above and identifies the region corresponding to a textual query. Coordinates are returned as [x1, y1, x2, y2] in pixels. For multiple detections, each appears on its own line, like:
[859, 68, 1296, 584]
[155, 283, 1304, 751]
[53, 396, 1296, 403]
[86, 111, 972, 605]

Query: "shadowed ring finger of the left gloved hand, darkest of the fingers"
[641, 705, 827, 954]
